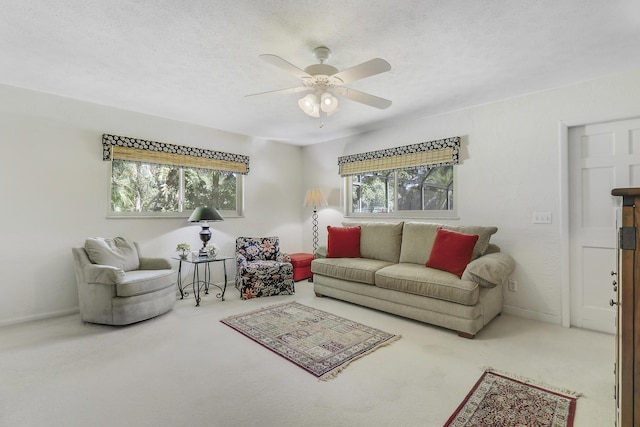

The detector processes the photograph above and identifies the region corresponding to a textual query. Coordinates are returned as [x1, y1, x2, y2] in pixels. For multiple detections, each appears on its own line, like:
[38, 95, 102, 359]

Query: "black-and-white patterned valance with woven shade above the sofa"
[338, 136, 460, 176]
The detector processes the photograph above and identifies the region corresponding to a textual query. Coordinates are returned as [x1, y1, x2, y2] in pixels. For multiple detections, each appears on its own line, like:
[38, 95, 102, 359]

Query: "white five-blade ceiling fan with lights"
[247, 46, 391, 127]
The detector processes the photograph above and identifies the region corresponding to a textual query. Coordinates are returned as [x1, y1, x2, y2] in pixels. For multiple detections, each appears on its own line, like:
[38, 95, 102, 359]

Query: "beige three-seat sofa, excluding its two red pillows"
[311, 222, 515, 338]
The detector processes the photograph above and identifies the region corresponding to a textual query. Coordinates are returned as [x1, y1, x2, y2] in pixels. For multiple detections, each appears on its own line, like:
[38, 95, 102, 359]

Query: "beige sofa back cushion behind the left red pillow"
[342, 222, 404, 262]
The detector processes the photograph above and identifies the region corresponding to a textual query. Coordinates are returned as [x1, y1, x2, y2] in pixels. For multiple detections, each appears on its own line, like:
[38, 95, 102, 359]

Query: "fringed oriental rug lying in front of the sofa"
[221, 302, 400, 380]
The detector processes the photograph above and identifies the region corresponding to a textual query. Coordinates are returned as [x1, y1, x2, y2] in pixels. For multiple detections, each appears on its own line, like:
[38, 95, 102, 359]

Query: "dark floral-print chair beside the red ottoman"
[236, 237, 295, 299]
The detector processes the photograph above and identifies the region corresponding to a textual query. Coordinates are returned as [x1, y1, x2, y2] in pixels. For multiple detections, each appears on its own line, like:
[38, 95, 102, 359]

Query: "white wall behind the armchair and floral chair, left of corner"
[0, 86, 305, 324]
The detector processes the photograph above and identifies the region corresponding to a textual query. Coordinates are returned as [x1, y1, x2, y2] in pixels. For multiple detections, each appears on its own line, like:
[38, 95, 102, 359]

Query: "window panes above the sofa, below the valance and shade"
[345, 165, 455, 217]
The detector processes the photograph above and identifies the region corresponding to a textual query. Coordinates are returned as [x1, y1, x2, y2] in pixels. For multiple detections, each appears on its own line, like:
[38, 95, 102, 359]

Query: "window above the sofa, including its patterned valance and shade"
[338, 137, 460, 218]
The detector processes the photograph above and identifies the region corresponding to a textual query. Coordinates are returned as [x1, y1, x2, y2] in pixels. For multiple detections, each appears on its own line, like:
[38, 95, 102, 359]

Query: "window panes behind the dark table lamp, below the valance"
[109, 160, 243, 217]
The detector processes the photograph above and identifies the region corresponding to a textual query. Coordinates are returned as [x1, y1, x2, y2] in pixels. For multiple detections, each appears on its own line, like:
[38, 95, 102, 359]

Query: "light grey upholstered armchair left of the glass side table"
[72, 237, 178, 325]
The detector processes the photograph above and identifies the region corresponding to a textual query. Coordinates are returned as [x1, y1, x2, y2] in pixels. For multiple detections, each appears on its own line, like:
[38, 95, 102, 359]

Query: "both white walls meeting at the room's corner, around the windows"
[5, 67, 640, 324]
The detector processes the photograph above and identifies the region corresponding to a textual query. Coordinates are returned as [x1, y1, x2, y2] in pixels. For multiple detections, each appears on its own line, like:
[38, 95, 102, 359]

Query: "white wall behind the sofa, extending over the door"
[303, 71, 640, 323]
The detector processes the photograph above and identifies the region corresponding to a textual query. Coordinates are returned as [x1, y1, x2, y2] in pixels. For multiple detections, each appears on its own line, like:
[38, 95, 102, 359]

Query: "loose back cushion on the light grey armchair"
[84, 237, 140, 271]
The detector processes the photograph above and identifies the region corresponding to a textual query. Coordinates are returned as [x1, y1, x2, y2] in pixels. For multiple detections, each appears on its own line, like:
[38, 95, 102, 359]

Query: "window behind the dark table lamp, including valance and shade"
[103, 135, 248, 217]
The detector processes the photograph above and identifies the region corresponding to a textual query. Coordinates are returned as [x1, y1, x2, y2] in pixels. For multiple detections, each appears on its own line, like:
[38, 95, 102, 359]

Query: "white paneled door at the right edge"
[569, 119, 640, 333]
